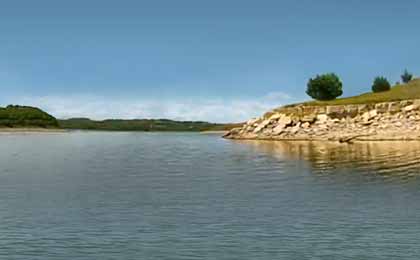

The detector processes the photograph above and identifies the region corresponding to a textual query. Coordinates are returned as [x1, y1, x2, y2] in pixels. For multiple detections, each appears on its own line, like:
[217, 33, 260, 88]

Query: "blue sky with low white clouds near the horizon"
[0, 0, 420, 122]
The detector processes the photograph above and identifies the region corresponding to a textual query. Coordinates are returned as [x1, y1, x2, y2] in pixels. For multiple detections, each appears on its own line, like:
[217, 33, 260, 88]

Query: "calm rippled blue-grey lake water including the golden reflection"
[0, 132, 420, 260]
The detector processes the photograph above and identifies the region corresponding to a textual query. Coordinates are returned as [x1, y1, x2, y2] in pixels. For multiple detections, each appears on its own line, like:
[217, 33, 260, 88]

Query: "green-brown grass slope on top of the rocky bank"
[290, 78, 420, 106]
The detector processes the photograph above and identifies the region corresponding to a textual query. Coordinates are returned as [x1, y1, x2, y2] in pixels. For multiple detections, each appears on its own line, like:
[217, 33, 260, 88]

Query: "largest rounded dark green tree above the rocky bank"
[306, 73, 343, 100]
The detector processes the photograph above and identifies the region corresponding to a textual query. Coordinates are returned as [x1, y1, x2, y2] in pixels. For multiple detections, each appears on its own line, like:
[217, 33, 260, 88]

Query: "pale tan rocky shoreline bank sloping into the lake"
[224, 99, 420, 142]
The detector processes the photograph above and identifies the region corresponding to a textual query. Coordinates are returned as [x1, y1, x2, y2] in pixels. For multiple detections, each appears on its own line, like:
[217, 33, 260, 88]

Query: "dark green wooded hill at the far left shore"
[0, 105, 58, 128]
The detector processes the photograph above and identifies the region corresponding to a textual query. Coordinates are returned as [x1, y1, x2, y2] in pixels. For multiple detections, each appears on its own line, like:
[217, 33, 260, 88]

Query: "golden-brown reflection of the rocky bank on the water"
[238, 141, 420, 176]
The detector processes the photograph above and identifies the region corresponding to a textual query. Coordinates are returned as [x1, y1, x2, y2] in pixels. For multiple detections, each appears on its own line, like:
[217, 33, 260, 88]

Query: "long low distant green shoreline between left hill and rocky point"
[59, 118, 234, 132]
